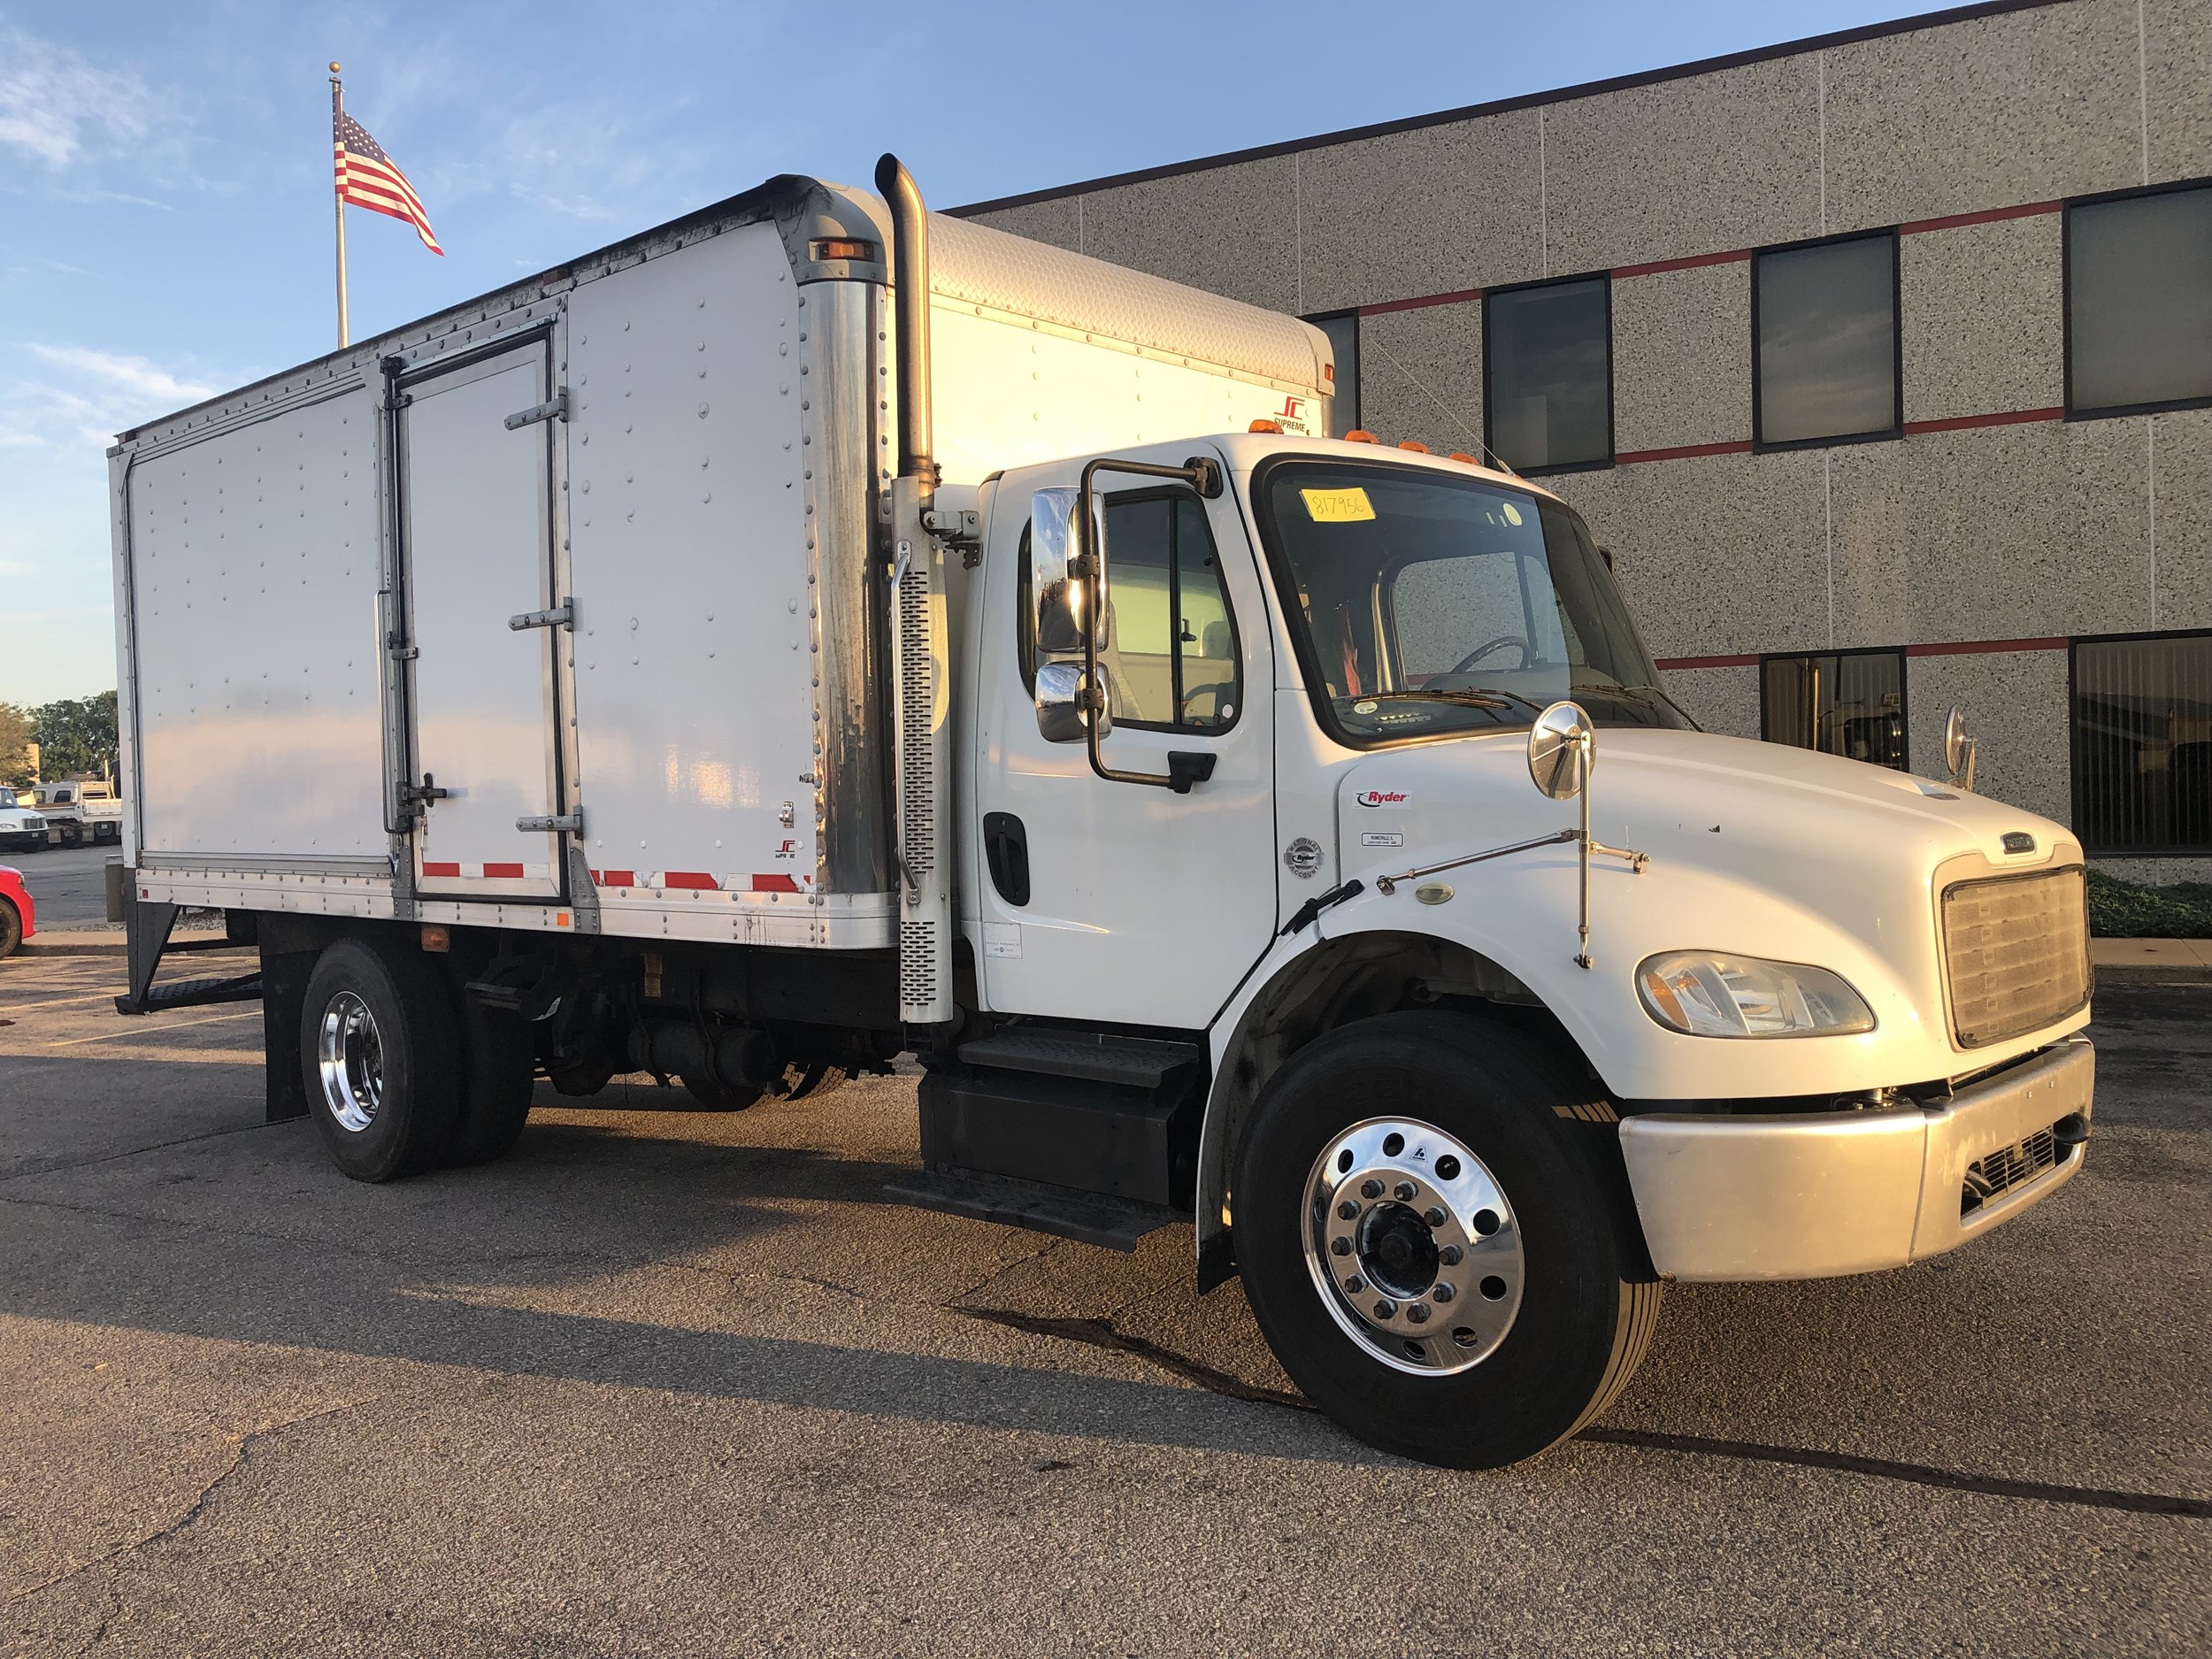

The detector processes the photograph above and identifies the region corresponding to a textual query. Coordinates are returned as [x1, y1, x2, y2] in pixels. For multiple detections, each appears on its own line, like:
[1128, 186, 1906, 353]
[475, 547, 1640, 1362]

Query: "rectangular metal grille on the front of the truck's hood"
[1942, 865, 2088, 1048]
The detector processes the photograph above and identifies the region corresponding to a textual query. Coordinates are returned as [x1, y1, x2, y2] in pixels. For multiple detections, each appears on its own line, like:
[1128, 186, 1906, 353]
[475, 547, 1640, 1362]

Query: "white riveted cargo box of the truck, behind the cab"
[111, 177, 1332, 947]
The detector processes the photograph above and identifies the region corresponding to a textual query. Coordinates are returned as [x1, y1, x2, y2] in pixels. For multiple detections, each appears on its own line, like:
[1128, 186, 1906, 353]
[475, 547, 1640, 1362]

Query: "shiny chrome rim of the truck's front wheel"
[1303, 1118, 1526, 1376]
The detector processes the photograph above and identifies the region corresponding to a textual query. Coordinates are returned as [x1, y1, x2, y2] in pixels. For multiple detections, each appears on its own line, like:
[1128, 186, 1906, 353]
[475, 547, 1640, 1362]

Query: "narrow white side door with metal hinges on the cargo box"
[401, 339, 565, 898]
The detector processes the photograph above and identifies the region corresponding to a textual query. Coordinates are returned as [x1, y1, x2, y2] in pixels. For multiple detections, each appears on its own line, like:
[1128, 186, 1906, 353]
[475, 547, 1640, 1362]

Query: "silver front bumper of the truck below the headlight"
[1622, 1038, 2097, 1281]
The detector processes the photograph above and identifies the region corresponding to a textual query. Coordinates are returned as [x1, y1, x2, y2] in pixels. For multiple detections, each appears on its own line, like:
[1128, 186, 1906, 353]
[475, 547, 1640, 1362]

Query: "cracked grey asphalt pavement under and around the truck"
[0, 956, 2212, 1657]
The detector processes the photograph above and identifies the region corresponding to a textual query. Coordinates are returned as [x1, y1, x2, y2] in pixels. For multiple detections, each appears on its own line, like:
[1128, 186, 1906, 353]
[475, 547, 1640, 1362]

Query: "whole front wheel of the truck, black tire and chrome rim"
[1233, 1013, 1662, 1469]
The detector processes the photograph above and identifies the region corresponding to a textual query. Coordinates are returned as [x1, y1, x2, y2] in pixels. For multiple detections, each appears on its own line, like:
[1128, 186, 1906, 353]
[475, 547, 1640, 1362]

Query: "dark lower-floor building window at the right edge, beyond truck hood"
[2073, 633, 2212, 852]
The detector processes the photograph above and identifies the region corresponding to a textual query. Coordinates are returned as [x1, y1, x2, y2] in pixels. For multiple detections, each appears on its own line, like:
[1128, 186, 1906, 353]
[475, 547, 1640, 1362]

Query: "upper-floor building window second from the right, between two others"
[1752, 230, 1905, 447]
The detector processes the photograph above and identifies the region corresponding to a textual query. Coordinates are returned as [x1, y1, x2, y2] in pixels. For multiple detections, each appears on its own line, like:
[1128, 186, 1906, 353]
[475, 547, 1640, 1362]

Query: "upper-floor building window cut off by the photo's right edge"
[2066, 186, 2212, 414]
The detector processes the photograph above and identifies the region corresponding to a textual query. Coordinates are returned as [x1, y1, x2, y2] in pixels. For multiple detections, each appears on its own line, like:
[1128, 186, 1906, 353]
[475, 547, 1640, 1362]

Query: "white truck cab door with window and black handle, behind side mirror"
[967, 447, 1277, 1031]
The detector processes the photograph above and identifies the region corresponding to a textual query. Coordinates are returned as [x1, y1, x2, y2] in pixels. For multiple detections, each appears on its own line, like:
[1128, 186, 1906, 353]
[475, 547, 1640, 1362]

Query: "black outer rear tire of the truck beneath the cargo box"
[299, 938, 460, 1181]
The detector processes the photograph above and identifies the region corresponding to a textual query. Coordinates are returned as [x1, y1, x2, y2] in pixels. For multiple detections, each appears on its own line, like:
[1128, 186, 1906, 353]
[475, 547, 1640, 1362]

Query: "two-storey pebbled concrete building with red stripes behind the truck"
[960, 0, 2212, 880]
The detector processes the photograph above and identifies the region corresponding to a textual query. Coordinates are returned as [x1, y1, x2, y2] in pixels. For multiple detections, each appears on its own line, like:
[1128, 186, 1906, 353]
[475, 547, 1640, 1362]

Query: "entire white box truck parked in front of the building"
[113, 157, 2093, 1467]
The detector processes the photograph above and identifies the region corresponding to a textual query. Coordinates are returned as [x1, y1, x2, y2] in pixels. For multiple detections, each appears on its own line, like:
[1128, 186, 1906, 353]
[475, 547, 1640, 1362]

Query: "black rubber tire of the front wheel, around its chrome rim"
[1233, 1013, 1663, 1469]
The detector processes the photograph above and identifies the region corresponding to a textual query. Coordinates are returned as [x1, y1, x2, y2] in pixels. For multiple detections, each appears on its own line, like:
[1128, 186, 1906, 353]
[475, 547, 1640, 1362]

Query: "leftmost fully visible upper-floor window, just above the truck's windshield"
[1482, 277, 1613, 473]
